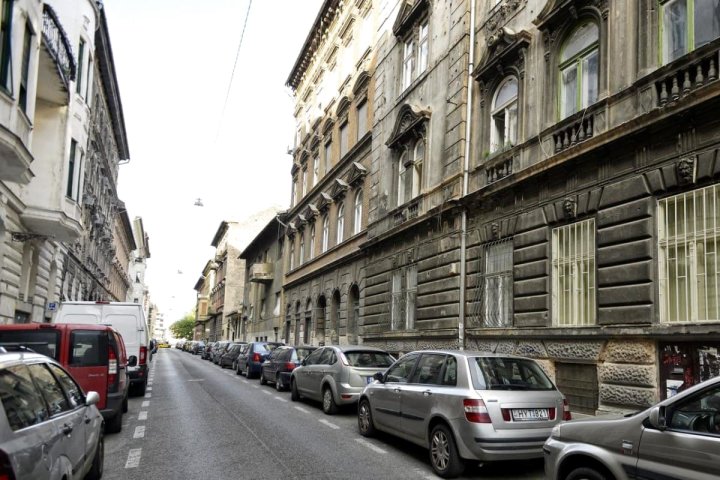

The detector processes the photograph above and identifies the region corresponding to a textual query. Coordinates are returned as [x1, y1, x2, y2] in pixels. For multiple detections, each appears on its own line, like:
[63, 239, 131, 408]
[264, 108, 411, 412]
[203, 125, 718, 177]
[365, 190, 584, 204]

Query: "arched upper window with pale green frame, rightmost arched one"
[560, 22, 599, 118]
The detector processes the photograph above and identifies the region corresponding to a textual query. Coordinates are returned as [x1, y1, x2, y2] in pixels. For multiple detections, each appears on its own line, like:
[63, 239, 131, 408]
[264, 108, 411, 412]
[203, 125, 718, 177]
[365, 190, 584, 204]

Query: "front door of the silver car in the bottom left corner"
[28, 363, 86, 478]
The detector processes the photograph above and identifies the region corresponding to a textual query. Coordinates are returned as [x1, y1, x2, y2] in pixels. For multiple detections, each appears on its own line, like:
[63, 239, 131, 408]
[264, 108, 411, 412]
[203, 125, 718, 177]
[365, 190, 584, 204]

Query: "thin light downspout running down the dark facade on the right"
[458, 0, 476, 350]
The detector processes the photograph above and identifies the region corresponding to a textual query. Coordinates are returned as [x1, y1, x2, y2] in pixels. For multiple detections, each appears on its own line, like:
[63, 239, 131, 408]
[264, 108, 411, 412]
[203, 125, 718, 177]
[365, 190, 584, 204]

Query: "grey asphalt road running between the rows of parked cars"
[103, 349, 544, 480]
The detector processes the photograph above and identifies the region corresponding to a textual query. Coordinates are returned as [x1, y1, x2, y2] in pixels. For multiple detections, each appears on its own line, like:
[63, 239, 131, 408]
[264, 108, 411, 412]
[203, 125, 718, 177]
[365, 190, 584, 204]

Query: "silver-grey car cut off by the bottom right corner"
[544, 377, 720, 480]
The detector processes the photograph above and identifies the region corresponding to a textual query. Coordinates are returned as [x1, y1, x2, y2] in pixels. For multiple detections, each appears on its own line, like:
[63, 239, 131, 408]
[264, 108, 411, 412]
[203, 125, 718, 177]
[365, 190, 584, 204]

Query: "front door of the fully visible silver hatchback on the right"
[368, 354, 420, 432]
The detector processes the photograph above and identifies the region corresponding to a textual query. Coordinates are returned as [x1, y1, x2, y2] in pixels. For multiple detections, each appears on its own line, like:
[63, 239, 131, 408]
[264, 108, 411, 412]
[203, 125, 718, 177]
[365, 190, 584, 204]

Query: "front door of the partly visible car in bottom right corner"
[637, 385, 720, 480]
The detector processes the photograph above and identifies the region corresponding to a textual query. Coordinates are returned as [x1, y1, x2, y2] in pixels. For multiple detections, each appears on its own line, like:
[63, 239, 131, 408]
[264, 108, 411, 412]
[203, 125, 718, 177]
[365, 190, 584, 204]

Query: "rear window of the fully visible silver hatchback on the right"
[468, 357, 555, 390]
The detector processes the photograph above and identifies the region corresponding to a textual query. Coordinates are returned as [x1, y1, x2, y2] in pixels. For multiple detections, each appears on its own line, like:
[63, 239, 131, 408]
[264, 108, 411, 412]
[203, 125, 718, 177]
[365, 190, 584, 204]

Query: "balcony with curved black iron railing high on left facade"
[37, 4, 76, 105]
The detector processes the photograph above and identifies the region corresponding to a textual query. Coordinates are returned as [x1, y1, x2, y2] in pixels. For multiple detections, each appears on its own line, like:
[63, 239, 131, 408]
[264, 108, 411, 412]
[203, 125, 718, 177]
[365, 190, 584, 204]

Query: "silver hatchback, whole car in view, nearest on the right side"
[358, 350, 570, 478]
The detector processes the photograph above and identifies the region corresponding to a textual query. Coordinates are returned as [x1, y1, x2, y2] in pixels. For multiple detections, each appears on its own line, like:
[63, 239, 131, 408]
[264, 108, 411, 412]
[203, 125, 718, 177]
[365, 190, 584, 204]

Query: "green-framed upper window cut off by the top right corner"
[660, 0, 720, 64]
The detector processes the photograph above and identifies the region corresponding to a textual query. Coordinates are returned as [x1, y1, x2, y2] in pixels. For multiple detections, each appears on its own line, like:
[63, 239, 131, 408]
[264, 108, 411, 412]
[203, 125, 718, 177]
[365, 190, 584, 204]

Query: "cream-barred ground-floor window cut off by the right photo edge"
[658, 184, 720, 323]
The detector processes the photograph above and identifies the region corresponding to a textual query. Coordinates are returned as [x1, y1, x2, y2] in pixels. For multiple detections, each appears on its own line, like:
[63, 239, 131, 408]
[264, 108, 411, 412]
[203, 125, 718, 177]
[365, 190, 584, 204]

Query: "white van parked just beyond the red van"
[53, 302, 150, 395]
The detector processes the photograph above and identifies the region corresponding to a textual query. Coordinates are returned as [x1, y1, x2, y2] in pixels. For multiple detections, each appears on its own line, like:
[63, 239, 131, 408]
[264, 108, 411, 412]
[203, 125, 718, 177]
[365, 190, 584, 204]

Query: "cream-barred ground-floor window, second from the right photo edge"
[552, 219, 595, 326]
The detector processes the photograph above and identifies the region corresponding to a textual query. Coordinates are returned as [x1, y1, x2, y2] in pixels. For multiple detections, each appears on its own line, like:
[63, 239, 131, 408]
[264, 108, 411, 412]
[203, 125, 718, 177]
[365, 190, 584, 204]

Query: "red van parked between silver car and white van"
[0, 323, 130, 436]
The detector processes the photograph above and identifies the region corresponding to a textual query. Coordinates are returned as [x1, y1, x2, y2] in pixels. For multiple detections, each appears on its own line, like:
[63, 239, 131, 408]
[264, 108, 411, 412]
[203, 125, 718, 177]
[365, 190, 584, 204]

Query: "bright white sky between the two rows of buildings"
[104, 0, 322, 325]
